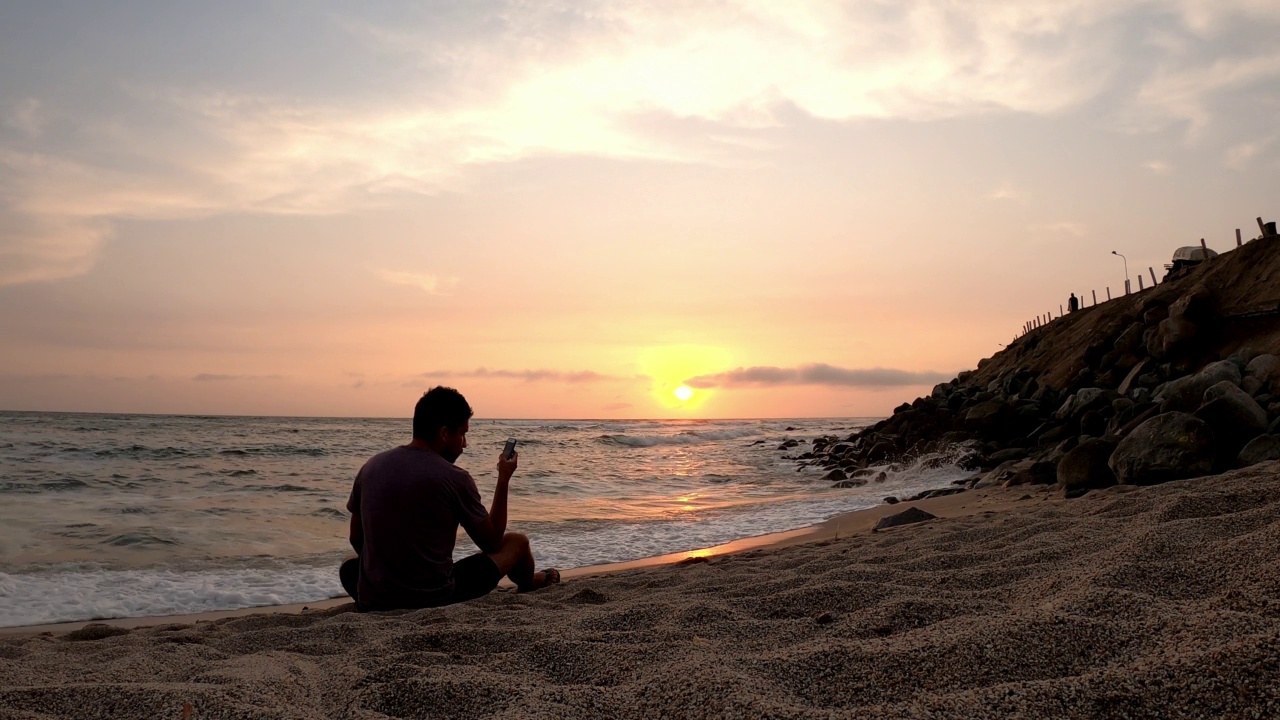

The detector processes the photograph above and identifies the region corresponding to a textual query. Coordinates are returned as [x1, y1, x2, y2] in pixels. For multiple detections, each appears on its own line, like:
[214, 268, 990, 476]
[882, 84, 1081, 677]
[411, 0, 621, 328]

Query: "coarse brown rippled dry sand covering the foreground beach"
[0, 462, 1280, 719]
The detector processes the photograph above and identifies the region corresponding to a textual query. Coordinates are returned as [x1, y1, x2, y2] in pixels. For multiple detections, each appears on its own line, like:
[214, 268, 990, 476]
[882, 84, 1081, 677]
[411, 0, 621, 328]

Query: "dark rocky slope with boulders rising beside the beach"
[797, 237, 1280, 496]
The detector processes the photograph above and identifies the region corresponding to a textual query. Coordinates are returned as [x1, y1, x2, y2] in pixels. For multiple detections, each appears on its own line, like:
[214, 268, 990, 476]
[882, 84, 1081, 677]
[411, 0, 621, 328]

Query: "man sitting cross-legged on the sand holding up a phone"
[339, 387, 559, 610]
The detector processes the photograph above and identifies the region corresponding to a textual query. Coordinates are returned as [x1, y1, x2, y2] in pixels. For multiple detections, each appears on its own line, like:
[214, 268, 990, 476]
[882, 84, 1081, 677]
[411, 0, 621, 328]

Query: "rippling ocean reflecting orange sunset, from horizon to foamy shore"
[0, 413, 966, 626]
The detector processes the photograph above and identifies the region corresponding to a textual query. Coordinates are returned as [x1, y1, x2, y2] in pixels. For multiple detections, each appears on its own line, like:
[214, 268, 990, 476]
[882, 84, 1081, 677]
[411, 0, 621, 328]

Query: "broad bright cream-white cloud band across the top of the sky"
[0, 0, 1280, 285]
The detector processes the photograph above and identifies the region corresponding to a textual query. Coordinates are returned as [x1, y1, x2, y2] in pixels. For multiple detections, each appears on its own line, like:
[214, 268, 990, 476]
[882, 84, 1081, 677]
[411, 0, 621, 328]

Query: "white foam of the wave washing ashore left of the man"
[0, 562, 343, 628]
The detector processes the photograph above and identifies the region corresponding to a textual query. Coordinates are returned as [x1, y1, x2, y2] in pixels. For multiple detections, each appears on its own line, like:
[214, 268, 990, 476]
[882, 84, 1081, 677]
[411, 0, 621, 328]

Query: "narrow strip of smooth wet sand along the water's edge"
[0, 488, 1029, 638]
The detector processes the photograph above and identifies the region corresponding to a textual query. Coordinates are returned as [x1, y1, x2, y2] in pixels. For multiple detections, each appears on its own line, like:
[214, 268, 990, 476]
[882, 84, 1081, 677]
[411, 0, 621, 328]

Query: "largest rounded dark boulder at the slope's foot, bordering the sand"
[1108, 413, 1213, 486]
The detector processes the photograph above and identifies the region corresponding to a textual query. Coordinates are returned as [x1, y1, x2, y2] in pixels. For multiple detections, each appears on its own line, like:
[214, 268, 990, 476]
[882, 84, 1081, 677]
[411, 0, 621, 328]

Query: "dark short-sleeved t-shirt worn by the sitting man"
[347, 446, 489, 610]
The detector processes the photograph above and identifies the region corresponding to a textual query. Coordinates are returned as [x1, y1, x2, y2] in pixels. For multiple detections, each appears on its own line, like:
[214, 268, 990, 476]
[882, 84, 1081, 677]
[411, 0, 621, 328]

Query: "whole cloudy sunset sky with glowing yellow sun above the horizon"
[0, 0, 1280, 418]
